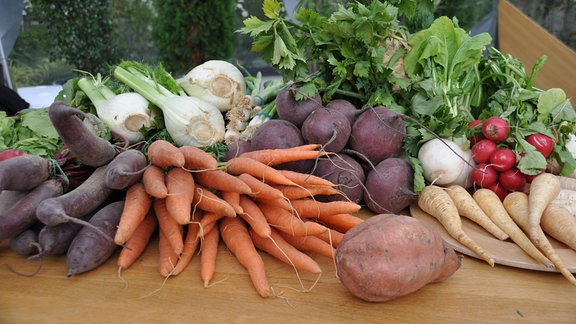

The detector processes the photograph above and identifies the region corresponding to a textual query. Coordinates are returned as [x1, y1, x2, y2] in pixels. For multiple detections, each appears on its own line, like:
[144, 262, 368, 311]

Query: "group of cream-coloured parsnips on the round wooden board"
[411, 173, 576, 285]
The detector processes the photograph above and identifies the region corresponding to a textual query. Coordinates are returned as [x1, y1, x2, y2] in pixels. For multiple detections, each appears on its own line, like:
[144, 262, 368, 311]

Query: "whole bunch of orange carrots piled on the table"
[115, 140, 362, 297]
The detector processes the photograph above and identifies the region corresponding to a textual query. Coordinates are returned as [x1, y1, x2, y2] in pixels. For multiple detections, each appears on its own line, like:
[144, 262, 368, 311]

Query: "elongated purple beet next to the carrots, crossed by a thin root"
[66, 200, 124, 277]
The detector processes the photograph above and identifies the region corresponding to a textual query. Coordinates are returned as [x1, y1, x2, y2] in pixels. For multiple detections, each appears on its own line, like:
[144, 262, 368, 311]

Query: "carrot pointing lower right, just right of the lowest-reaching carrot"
[250, 229, 322, 274]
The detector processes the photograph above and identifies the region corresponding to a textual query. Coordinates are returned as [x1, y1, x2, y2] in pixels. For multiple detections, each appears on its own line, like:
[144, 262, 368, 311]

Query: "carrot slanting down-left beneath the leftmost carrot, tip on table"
[116, 210, 158, 271]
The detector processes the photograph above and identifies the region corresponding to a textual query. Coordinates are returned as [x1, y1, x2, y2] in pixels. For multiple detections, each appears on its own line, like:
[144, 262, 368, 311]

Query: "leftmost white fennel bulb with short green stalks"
[78, 77, 154, 143]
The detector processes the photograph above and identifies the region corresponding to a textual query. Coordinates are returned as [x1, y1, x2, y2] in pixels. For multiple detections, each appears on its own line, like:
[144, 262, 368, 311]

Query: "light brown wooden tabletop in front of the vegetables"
[0, 216, 576, 324]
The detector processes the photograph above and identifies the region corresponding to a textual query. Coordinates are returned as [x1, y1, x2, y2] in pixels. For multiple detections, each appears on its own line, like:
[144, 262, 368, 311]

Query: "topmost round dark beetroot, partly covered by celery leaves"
[276, 86, 322, 128]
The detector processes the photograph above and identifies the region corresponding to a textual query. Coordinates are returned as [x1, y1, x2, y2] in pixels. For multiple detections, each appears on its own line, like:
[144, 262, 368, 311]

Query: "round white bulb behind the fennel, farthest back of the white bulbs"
[176, 60, 246, 112]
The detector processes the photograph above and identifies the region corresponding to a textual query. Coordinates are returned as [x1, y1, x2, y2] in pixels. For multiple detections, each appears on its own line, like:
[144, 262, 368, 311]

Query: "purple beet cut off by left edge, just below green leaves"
[0, 155, 51, 191]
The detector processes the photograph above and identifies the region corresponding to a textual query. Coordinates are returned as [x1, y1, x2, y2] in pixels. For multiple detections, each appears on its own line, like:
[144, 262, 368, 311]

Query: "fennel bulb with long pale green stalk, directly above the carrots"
[114, 66, 225, 147]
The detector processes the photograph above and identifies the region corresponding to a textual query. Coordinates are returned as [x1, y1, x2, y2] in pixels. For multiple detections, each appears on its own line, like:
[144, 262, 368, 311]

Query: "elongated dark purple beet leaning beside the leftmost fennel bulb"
[48, 101, 116, 167]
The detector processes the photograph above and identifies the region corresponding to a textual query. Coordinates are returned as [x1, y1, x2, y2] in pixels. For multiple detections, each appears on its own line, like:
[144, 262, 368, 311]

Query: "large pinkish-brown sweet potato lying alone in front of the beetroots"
[336, 214, 461, 302]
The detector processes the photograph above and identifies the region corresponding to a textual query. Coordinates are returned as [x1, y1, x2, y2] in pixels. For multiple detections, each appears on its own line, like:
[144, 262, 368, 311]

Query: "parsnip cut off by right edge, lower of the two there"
[540, 204, 576, 251]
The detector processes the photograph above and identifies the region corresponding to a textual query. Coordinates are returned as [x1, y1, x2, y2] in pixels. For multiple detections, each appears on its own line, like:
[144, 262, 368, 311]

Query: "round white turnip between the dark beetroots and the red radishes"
[418, 138, 467, 186]
